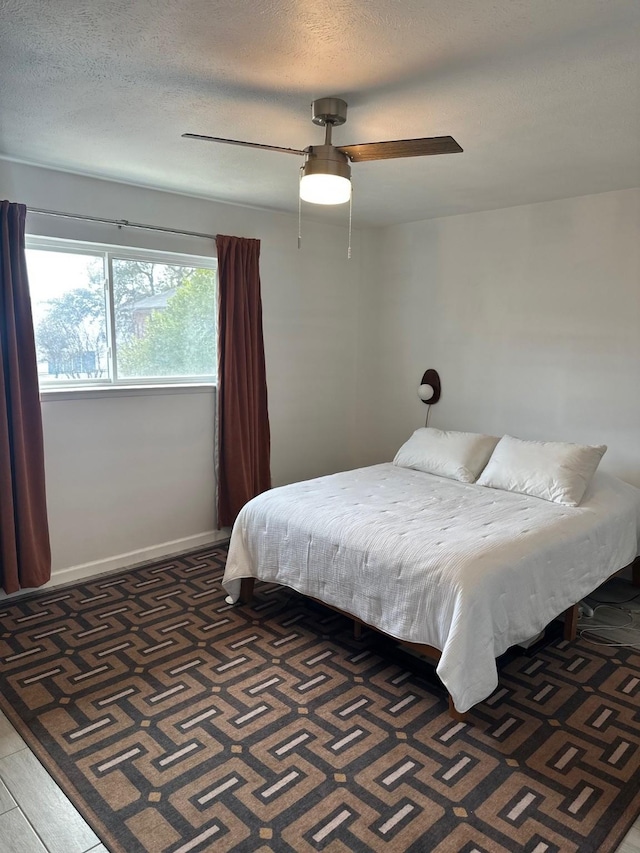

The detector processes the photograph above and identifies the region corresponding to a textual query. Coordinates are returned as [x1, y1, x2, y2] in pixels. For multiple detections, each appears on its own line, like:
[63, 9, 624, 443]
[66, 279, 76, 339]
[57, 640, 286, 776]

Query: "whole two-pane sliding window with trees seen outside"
[26, 238, 217, 388]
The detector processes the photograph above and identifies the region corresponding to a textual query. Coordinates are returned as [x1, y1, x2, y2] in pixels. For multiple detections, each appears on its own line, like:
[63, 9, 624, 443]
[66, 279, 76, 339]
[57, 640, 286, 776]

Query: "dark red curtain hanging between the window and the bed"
[216, 234, 271, 527]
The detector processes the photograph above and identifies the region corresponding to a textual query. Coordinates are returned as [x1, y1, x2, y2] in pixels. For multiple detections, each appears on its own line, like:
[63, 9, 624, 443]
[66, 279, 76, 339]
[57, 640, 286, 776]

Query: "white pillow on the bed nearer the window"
[393, 427, 498, 483]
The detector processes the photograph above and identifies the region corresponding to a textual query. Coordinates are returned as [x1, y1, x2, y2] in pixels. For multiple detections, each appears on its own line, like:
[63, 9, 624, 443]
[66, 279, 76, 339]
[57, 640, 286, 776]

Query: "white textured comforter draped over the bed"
[223, 464, 640, 711]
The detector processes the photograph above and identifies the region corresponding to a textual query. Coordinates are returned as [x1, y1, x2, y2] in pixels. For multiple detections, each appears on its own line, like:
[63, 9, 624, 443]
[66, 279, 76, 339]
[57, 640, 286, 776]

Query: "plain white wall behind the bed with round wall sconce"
[358, 190, 640, 485]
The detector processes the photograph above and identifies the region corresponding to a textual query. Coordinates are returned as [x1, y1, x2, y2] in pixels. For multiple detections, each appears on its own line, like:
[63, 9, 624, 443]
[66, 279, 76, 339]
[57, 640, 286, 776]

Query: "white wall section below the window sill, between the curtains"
[42, 388, 215, 581]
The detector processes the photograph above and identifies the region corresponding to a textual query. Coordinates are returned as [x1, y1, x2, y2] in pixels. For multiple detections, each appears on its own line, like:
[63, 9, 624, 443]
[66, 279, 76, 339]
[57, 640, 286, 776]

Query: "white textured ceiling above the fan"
[0, 0, 640, 225]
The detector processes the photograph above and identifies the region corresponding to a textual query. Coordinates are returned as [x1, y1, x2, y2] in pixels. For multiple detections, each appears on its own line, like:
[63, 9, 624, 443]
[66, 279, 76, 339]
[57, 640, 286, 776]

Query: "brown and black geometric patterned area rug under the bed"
[0, 545, 640, 853]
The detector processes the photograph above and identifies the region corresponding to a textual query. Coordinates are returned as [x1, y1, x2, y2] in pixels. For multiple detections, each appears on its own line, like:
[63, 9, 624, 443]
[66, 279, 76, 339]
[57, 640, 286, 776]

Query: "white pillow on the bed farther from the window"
[478, 435, 607, 506]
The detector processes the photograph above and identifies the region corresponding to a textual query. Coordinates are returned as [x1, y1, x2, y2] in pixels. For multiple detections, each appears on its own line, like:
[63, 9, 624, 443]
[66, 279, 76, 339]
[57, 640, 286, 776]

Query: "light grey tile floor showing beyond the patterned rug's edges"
[0, 580, 640, 853]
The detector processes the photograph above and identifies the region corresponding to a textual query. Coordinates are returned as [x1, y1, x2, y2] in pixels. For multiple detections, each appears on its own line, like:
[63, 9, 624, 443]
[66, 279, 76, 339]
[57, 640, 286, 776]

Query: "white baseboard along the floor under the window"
[0, 528, 230, 598]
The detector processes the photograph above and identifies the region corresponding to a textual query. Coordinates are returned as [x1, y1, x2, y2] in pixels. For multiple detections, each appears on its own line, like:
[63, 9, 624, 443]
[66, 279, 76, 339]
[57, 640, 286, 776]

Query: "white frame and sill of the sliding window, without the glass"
[25, 234, 218, 397]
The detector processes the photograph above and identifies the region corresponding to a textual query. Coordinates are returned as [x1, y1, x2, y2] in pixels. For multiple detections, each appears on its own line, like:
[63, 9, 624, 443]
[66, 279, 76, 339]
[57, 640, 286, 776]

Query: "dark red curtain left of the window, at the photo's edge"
[0, 201, 51, 593]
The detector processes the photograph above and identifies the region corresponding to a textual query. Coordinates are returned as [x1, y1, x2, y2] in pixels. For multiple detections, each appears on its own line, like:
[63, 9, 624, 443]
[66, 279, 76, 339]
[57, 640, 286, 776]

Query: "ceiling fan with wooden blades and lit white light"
[182, 98, 462, 204]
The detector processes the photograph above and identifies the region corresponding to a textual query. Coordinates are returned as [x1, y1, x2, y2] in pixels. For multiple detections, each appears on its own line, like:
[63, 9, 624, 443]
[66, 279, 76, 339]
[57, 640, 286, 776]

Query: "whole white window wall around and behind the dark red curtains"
[0, 160, 360, 580]
